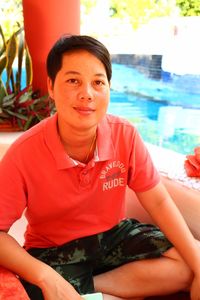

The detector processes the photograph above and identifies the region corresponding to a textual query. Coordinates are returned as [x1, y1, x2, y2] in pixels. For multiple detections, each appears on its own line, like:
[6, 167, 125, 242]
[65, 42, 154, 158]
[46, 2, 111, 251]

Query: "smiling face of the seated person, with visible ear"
[48, 50, 110, 130]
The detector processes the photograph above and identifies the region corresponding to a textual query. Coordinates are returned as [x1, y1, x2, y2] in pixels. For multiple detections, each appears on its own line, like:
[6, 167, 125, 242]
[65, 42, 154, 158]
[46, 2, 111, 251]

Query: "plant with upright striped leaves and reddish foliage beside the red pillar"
[0, 26, 54, 131]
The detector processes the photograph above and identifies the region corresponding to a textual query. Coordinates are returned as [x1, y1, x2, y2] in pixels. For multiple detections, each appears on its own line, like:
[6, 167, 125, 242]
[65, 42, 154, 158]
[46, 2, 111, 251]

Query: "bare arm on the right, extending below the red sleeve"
[137, 182, 200, 284]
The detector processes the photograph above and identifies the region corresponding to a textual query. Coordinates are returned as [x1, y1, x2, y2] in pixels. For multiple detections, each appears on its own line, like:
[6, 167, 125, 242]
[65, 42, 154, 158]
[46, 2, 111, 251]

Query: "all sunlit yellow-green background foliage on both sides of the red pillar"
[0, 0, 200, 36]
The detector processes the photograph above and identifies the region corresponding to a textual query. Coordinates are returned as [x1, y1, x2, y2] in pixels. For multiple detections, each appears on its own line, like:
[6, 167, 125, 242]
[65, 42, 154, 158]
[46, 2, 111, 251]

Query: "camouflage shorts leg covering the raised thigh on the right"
[95, 219, 172, 275]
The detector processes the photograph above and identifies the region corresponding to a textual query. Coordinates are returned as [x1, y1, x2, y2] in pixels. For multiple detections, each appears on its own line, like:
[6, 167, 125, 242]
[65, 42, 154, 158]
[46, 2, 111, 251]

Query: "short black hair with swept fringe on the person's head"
[46, 35, 112, 83]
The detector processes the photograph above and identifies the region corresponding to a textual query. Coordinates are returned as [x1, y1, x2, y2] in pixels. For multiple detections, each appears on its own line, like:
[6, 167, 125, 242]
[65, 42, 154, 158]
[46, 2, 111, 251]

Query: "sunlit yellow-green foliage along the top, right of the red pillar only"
[81, 0, 200, 29]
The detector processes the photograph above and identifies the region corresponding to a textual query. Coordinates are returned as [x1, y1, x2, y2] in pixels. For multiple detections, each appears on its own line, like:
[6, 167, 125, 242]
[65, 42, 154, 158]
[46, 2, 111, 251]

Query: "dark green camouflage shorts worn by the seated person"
[22, 219, 172, 300]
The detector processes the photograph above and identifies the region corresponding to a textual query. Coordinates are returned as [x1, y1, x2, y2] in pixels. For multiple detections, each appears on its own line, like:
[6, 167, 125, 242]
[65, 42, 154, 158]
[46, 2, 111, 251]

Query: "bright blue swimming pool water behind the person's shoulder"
[109, 64, 200, 154]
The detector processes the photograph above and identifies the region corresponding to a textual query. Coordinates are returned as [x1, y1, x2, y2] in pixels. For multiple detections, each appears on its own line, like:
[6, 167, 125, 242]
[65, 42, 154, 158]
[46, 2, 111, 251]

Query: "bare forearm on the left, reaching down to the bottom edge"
[0, 231, 82, 300]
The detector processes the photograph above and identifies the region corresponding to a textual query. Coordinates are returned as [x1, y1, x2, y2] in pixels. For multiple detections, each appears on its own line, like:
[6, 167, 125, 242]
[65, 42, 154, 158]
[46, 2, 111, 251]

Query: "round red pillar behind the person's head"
[23, 0, 80, 95]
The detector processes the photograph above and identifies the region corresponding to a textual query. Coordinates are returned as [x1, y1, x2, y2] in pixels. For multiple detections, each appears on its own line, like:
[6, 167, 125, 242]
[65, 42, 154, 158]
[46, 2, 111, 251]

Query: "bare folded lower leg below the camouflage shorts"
[94, 248, 193, 300]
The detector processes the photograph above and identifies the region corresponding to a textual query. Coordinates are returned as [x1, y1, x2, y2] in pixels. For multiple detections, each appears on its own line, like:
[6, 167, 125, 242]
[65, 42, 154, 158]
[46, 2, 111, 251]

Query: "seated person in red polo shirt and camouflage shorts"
[0, 36, 200, 300]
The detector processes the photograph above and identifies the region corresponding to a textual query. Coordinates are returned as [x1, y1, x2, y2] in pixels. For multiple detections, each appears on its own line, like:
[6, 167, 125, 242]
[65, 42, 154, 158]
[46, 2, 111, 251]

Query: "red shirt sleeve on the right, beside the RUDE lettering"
[128, 130, 160, 192]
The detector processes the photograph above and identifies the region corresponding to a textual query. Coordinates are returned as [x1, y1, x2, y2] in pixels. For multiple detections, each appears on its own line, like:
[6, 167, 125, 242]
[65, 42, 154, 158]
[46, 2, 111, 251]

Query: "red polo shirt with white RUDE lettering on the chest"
[0, 114, 159, 248]
